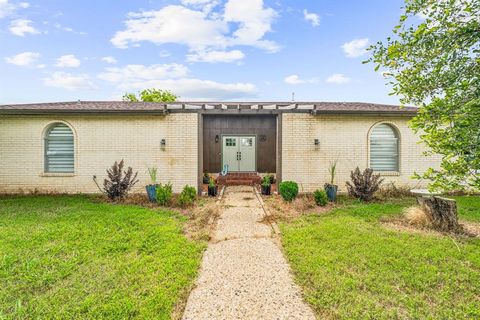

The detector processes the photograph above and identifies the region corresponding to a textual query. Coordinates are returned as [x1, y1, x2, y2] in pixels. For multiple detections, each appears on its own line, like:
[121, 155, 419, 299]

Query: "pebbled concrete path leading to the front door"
[183, 186, 315, 320]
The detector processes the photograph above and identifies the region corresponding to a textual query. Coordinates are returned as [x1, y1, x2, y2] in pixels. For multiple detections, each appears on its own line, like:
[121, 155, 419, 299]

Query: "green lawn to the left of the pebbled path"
[0, 196, 205, 319]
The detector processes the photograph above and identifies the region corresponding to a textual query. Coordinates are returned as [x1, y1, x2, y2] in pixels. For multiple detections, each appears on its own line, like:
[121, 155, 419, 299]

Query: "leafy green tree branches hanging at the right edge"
[366, 0, 480, 190]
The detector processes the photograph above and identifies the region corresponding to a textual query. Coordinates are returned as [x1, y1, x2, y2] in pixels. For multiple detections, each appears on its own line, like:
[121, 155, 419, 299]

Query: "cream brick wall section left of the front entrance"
[0, 113, 198, 193]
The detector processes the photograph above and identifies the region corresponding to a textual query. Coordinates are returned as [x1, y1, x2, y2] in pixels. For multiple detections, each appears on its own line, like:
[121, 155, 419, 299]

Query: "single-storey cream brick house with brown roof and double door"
[0, 101, 439, 193]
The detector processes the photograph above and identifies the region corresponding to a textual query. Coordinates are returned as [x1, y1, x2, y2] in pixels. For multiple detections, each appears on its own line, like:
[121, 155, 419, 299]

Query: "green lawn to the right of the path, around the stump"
[281, 197, 480, 319]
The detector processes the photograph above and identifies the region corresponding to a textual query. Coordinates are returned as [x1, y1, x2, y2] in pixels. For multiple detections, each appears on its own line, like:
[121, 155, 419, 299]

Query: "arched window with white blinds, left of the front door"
[45, 123, 74, 173]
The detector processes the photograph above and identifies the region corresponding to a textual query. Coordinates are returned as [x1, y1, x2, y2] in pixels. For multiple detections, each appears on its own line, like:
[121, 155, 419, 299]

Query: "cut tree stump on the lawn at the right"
[422, 197, 461, 232]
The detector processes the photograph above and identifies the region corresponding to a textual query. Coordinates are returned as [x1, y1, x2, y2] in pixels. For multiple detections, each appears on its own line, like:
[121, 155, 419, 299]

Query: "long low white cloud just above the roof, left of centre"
[98, 63, 257, 100]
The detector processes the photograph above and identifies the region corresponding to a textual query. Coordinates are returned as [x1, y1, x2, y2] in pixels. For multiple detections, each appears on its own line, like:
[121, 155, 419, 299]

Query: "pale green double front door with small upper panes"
[222, 136, 256, 172]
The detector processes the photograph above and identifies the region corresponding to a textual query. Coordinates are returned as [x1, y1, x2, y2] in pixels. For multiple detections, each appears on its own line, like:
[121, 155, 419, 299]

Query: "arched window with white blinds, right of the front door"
[370, 123, 399, 171]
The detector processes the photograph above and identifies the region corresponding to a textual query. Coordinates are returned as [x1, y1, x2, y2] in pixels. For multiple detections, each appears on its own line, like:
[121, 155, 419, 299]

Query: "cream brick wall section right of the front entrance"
[282, 113, 440, 192]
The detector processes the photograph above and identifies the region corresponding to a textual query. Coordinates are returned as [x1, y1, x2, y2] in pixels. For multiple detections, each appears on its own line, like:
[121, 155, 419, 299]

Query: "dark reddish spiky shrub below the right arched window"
[347, 167, 384, 201]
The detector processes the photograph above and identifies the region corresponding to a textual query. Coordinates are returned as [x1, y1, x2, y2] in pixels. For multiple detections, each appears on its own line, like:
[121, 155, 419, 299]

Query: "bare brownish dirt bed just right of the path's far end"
[262, 194, 335, 223]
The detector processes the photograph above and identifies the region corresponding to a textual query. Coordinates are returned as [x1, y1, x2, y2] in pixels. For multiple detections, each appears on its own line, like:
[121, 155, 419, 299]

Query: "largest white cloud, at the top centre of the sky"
[111, 0, 279, 61]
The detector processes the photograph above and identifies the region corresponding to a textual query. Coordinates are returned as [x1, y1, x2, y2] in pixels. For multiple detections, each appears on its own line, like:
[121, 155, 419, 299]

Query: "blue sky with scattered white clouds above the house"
[0, 0, 403, 104]
